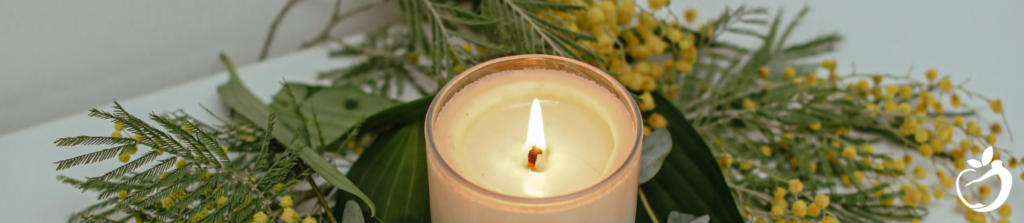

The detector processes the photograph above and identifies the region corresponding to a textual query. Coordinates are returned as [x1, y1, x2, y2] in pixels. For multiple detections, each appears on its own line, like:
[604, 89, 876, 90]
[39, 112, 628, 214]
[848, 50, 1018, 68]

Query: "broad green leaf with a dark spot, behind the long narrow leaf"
[270, 83, 395, 147]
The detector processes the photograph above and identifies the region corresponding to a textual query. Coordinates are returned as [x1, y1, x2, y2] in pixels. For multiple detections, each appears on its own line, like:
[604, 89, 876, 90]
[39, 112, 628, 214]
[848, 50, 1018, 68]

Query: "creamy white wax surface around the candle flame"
[434, 70, 636, 197]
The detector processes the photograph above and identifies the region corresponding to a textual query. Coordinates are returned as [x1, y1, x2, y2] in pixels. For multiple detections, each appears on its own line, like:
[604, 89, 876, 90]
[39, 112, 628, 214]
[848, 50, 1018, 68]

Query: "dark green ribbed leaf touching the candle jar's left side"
[334, 119, 430, 222]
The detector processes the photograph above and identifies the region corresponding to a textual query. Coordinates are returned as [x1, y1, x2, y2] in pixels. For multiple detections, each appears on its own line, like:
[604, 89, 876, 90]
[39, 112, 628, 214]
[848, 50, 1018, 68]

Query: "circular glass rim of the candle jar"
[424, 54, 643, 204]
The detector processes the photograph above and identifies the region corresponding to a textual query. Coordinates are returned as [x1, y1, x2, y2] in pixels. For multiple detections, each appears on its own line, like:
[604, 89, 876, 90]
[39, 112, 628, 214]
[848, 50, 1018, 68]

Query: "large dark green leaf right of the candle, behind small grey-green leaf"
[637, 94, 743, 222]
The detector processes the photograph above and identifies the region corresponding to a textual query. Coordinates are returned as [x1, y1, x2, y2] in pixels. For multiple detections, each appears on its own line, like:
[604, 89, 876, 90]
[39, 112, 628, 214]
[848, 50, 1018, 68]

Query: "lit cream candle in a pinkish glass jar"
[425, 55, 642, 222]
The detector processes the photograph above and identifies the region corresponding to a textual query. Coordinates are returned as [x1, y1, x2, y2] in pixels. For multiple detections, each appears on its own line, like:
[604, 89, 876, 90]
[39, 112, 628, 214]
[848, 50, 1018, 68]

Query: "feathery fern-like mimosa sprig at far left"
[54, 101, 308, 222]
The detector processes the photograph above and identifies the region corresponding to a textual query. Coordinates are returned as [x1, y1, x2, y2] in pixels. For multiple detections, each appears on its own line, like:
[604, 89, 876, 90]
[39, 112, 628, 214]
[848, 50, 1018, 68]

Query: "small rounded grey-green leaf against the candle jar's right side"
[640, 128, 672, 183]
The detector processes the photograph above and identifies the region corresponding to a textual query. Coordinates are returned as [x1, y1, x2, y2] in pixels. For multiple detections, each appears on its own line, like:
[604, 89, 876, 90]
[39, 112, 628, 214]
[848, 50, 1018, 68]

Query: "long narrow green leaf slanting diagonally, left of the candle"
[217, 53, 377, 215]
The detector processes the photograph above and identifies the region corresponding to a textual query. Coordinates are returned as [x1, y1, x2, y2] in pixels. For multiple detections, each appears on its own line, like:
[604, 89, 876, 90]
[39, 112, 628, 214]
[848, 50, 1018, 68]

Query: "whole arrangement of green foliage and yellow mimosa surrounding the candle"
[55, 0, 1019, 223]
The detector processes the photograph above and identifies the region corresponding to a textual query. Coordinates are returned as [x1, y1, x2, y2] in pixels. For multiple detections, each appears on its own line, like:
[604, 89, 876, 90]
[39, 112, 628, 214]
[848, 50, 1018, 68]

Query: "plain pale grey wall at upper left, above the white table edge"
[0, 0, 397, 135]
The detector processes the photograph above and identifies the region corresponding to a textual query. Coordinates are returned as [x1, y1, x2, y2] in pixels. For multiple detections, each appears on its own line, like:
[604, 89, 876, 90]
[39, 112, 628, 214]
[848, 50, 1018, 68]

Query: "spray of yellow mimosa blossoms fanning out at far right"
[696, 59, 1024, 222]
